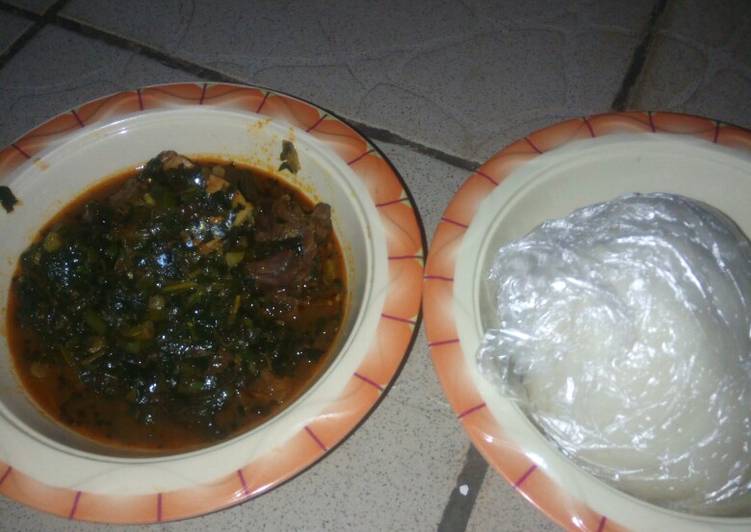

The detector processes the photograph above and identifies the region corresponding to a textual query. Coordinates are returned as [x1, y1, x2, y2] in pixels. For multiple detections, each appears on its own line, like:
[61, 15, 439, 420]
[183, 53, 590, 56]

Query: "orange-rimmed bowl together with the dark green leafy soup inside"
[0, 84, 422, 522]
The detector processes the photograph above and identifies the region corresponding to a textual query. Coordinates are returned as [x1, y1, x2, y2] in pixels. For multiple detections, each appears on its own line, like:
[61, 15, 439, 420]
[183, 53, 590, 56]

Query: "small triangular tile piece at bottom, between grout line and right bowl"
[467, 469, 560, 532]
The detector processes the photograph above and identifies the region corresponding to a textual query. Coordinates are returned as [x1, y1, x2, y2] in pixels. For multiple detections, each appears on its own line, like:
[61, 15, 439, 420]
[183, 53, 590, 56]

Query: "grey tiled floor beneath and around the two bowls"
[0, 0, 751, 531]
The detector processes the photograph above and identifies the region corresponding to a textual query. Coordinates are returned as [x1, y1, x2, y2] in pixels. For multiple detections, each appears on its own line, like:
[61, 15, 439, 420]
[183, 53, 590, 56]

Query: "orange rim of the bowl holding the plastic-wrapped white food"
[423, 112, 751, 531]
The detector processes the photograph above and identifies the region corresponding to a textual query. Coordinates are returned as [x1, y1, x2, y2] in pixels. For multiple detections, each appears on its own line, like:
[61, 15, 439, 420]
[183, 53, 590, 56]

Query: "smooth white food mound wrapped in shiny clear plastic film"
[477, 194, 751, 515]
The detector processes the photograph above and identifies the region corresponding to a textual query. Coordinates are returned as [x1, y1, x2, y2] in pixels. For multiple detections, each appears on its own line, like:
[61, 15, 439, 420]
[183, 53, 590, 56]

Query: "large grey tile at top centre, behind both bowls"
[63, 0, 653, 160]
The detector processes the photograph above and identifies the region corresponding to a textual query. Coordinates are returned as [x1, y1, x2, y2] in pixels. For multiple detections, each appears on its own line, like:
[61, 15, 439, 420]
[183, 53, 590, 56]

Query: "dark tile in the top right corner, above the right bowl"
[631, 0, 751, 127]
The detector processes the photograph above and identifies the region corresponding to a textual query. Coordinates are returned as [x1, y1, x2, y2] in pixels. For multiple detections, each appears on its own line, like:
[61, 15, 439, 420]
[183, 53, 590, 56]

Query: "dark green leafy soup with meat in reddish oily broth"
[7, 152, 347, 452]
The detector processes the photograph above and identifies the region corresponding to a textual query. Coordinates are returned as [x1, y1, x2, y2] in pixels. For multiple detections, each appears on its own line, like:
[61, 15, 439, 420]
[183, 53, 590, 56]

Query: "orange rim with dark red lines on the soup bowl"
[0, 82, 426, 523]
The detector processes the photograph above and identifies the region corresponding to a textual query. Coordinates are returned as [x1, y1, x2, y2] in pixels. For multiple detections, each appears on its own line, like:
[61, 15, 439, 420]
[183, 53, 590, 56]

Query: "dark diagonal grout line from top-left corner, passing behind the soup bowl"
[0, 0, 481, 171]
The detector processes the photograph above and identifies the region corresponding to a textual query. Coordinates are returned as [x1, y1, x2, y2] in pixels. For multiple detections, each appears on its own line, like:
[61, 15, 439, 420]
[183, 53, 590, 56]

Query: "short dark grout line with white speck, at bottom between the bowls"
[438, 445, 488, 532]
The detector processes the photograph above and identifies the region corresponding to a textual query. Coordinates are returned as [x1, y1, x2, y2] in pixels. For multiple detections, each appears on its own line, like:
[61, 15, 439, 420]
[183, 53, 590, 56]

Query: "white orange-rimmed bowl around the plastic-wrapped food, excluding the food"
[424, 114, 751, 530]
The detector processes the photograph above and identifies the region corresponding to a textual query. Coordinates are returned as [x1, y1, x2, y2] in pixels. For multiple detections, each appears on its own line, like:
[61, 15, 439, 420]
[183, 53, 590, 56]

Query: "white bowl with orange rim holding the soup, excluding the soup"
[0, 84, 421, 522]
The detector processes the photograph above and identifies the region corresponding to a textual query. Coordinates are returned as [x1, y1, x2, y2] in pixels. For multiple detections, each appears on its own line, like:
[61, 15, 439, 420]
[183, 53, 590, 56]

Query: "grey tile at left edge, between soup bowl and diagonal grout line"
[0, 26, 196, 146]
